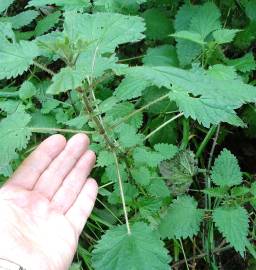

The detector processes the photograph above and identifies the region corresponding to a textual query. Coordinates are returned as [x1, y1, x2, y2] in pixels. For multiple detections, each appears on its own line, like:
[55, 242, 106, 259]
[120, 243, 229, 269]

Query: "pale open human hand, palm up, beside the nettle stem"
[0, 134, 98, 270]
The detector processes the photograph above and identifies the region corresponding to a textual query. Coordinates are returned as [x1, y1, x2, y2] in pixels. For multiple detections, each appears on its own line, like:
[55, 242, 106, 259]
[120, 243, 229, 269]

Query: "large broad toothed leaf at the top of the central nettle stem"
[64, 12, 145, 53]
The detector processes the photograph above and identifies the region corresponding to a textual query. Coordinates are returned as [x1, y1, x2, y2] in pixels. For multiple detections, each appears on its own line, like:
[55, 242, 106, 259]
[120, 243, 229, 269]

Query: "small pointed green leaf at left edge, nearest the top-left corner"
[0, 10, 39, 29]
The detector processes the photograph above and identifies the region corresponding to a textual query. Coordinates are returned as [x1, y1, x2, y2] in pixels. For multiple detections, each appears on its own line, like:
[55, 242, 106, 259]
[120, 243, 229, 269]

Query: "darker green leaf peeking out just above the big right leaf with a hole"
[143, 45, 178, 67]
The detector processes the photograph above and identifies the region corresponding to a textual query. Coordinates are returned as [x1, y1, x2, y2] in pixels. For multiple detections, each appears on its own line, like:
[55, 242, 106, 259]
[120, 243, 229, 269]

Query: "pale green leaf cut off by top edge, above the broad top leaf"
[28, 0, 89, 10]
